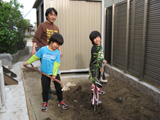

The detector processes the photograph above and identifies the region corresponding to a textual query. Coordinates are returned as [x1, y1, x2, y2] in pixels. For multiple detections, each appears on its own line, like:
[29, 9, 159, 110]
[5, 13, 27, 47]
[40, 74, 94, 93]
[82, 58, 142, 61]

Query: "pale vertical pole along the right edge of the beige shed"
[101, 0, 105, 50]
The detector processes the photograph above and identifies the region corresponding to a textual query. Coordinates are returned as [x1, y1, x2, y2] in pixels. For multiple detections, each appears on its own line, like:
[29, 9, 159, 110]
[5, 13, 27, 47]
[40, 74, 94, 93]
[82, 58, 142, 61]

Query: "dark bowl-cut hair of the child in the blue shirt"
[48, 32, 64, 45]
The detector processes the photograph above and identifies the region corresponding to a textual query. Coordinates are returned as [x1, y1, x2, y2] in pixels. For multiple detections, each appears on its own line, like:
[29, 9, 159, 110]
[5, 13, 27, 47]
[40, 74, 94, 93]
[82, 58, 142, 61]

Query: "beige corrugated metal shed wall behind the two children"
[46, 0, 101, 71]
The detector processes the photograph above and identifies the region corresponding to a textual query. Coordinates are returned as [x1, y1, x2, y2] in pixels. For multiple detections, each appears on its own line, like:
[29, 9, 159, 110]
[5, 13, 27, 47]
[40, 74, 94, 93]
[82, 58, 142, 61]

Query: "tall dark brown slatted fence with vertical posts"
[105, 0, 160, 84]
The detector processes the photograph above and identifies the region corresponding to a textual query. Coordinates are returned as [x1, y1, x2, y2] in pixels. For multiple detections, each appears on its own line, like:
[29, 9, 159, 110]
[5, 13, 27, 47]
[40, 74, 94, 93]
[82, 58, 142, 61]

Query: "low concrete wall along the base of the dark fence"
[105, 64, 160, 104]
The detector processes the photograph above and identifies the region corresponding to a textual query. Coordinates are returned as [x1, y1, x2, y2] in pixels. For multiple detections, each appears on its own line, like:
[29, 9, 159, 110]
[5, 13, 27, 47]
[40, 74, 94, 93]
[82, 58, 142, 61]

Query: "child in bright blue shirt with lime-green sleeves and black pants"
[23, 33, 69, 112]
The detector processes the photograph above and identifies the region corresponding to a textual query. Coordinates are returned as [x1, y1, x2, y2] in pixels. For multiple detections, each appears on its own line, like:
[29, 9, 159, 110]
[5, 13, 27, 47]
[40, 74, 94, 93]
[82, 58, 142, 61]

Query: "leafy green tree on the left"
[0, 0, 30, 54]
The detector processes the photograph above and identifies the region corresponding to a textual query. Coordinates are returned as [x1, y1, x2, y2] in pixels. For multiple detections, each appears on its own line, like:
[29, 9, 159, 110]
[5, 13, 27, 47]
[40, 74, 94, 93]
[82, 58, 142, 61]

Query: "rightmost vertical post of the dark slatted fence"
[140, 0, 148, 80]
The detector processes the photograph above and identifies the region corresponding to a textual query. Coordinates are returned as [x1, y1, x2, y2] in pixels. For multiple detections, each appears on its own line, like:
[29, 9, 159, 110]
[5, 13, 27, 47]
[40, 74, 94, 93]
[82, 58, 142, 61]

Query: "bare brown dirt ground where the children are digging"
[23, 68, 160, 120]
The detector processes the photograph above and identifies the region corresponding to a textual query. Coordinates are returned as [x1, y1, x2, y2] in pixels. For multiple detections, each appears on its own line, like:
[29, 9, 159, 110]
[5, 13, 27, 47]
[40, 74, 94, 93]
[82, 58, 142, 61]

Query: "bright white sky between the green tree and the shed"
[3, 0, 36, 26]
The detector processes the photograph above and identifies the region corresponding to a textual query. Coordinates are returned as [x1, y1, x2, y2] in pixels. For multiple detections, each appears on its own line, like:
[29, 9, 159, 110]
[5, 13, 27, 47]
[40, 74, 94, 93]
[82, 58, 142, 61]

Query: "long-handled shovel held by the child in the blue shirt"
[25, 64, 70, 91]
